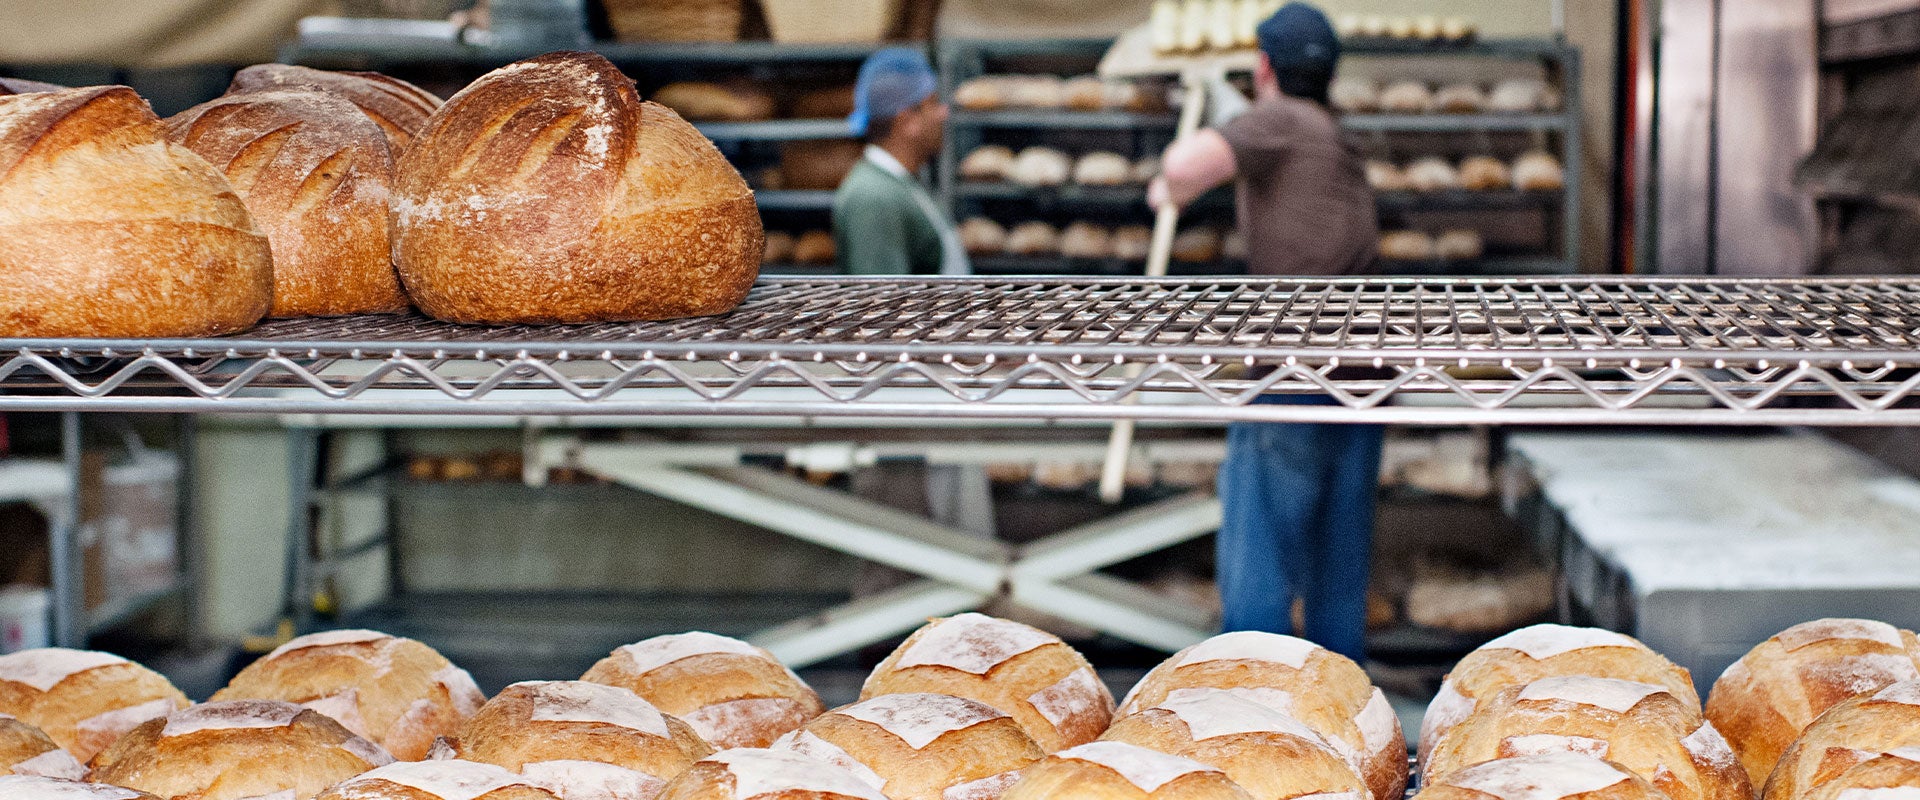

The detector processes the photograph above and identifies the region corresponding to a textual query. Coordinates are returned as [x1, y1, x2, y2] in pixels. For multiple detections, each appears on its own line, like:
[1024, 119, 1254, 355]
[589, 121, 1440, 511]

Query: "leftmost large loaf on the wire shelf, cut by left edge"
[0, 86, 273, 337]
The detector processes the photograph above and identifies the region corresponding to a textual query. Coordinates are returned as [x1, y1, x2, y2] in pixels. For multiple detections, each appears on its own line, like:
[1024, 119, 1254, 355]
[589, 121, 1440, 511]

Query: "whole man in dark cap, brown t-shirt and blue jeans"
[1148, 2, 1382, 660]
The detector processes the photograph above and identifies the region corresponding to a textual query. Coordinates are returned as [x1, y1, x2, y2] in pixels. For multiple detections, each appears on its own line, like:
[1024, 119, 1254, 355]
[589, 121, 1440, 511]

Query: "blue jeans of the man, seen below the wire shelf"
[1213, 395, 1384, 662]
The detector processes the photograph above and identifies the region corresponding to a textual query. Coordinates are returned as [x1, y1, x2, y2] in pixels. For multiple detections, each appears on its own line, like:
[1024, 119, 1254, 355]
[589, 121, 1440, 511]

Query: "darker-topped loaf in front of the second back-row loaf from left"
[92, 700, 392, 800]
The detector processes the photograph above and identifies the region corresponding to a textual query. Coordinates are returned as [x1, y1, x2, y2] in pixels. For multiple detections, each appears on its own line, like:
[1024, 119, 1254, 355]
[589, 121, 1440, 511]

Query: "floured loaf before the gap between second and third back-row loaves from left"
[453, 681, 714, 800]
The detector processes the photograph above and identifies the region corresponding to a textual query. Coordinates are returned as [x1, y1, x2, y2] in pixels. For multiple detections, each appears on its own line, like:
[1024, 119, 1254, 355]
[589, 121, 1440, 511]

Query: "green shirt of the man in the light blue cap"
[833, 159, 945, 274]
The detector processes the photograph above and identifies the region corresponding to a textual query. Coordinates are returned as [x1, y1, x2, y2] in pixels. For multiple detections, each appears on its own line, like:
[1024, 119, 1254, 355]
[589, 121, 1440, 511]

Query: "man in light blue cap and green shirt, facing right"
[833, 48, 972, 274]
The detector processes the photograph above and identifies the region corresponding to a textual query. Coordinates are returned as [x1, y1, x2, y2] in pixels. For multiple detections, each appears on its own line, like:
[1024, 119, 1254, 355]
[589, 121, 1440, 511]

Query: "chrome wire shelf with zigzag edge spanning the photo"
[0, 278, 1920, 424]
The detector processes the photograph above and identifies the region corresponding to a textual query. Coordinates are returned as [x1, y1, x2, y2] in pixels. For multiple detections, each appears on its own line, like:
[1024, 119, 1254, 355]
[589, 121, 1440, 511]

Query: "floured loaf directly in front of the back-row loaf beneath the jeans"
[1100, 689, 1379, 800]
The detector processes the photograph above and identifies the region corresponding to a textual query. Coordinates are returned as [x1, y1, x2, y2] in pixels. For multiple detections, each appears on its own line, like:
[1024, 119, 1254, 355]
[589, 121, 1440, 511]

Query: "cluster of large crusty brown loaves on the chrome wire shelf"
[0, 54, 762, 338]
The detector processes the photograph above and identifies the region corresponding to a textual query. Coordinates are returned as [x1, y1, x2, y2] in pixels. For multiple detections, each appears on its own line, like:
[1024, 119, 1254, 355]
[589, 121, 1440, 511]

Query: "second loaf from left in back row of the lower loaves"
[213, 629, 486, 762]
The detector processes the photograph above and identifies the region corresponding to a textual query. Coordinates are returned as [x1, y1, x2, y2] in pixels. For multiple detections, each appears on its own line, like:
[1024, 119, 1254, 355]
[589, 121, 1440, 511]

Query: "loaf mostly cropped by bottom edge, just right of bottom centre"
[1000, 742, 1252, 800]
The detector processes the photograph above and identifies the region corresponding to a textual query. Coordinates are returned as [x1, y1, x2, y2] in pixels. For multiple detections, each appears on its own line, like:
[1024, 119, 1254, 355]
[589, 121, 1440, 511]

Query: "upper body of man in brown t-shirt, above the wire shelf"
[1148, 2, 1379, 274]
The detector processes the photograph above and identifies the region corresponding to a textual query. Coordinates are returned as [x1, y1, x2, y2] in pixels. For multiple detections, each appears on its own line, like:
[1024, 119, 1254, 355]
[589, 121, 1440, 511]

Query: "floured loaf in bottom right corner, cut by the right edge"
[1763, 681, 1920, 800]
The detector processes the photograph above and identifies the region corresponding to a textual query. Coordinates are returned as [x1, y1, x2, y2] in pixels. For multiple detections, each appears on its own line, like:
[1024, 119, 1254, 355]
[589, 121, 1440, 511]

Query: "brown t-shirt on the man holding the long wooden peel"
[1221, 96, 1380, 274]
